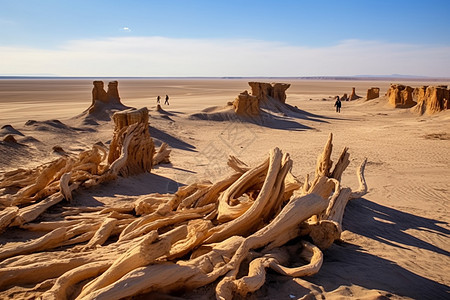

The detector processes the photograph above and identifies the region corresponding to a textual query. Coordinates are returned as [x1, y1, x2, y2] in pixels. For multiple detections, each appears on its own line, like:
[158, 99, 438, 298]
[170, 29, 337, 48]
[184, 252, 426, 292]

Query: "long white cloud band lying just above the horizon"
[0, 37, 450, 77]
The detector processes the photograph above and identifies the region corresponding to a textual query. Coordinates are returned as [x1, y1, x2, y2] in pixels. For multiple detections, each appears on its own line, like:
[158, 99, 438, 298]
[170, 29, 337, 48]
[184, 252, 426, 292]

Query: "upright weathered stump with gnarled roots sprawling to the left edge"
[0, 108, 165, 232]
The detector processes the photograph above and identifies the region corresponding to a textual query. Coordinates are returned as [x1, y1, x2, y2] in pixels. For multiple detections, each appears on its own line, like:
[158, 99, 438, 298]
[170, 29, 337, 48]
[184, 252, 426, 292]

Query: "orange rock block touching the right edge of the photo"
[412, 85, 450, 114]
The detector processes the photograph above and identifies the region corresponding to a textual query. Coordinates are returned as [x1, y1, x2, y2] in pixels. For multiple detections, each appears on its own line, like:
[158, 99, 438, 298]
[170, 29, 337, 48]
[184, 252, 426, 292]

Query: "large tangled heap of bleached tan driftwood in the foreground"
[0, 135, 367, 299]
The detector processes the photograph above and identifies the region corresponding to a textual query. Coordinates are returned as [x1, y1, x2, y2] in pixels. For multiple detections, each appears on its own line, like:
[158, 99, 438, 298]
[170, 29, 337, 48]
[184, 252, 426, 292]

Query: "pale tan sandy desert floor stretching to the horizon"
[0, 78, 450, 299]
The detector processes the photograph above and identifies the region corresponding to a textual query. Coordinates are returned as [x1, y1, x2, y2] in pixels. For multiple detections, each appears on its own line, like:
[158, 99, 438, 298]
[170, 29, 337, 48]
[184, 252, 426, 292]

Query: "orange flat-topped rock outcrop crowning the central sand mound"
[233, 82, 291, 116]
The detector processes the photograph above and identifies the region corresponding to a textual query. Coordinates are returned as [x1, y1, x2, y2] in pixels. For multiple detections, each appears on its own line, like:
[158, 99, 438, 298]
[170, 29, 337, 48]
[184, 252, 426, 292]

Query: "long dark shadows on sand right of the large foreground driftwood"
[307, 198, 450, 299]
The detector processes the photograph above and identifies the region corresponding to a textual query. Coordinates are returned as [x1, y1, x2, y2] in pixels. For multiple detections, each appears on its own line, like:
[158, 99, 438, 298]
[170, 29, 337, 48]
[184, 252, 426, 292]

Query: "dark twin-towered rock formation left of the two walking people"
[88, 80, 128, 114]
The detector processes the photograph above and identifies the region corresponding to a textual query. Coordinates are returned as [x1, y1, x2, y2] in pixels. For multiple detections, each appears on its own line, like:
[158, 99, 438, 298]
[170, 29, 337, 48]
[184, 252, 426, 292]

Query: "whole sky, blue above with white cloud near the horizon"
[0, 0, 450, 77]
